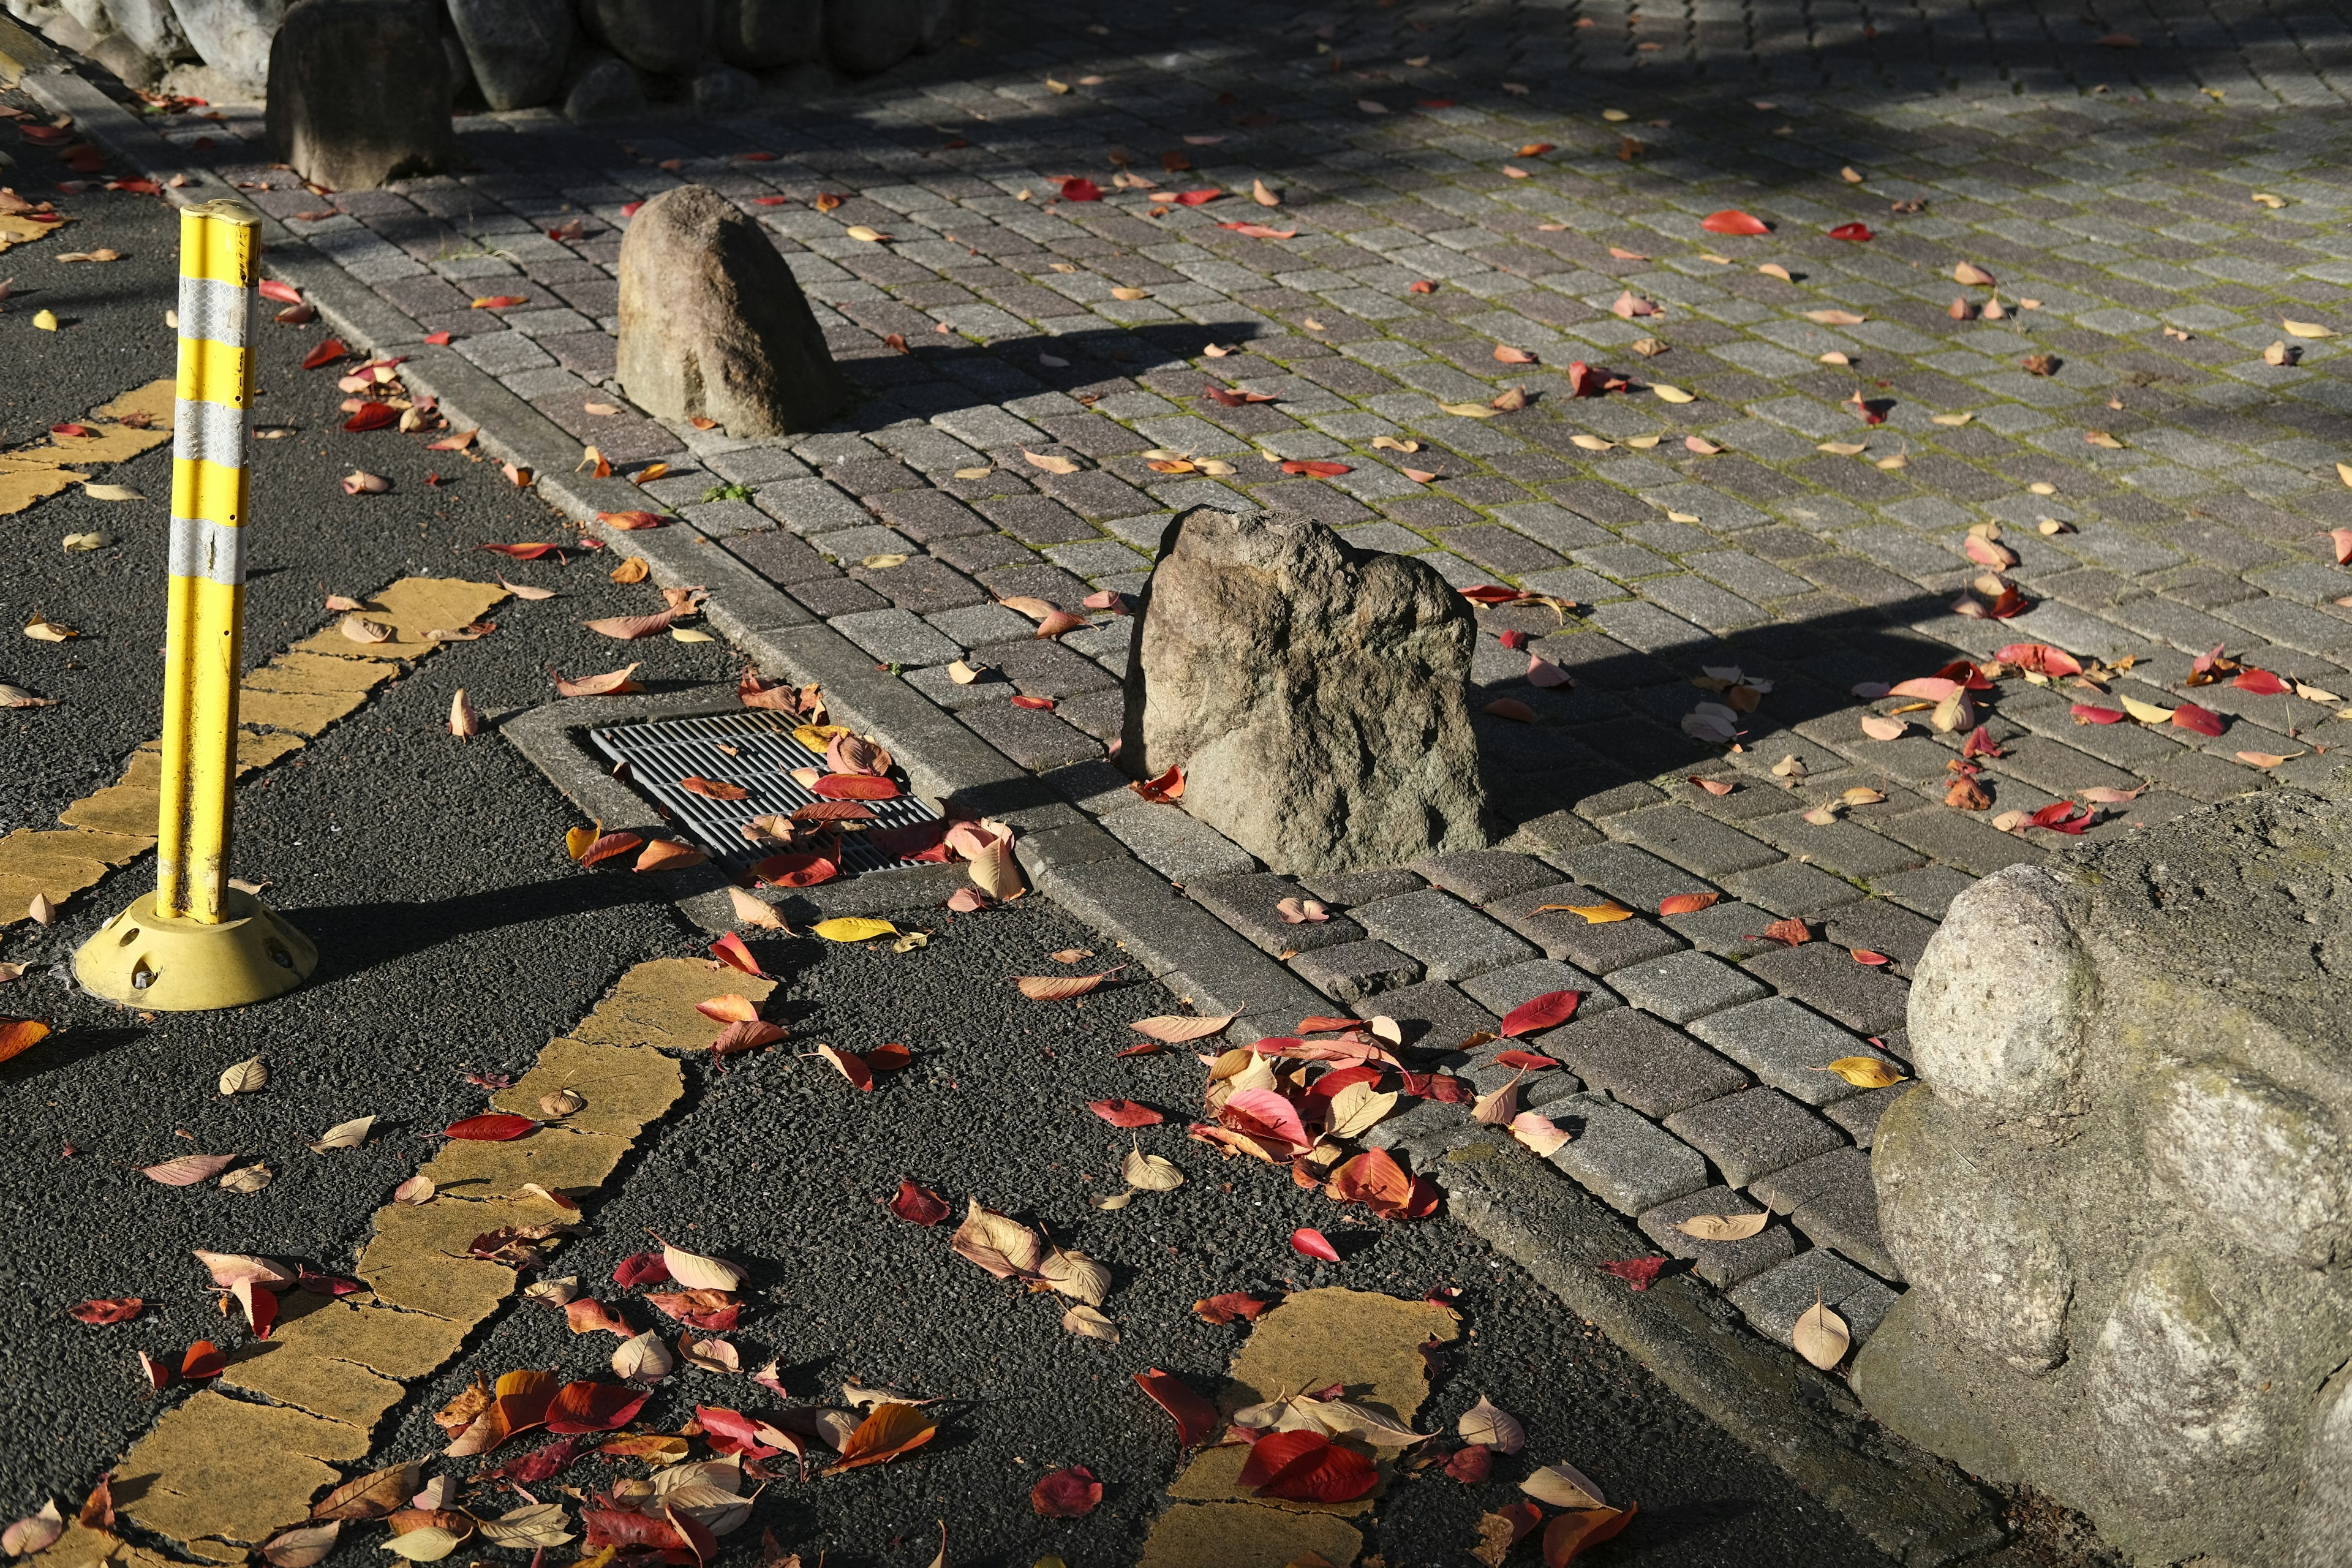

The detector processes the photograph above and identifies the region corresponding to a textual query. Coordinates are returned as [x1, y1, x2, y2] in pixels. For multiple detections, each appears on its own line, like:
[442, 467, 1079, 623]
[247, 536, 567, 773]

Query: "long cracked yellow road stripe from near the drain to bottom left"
[59, 959, 748, 1568]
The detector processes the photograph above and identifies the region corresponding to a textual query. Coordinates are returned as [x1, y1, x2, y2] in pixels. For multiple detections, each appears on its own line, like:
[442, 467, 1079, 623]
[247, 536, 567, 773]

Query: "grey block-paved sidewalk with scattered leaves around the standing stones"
[83, 0, 2352, 1373]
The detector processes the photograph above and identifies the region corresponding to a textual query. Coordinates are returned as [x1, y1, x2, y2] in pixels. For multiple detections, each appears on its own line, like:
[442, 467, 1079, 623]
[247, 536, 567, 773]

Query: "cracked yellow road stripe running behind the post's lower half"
[0, 576, 506, 926]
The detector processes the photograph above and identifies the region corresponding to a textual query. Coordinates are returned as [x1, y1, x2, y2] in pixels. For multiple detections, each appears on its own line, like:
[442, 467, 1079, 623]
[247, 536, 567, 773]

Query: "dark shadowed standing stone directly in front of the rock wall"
[266, 0, 459, 190]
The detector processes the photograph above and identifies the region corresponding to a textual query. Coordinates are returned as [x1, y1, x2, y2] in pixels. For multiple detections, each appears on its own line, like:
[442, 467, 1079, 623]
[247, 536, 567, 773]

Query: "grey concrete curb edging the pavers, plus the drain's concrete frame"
[41, 73, 2002, 1568]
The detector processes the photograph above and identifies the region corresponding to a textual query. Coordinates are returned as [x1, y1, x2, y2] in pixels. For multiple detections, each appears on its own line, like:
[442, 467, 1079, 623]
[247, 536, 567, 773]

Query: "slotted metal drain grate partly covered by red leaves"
[588, 712, 938, 872]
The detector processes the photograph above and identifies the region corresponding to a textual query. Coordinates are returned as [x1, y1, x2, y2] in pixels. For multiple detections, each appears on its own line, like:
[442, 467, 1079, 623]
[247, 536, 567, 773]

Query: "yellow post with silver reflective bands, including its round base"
[73, 200, 317, 1011]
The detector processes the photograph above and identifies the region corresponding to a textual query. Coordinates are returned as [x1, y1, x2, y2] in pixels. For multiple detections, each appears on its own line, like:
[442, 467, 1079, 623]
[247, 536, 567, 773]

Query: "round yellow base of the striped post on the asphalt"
[73, 889, 317, 1013]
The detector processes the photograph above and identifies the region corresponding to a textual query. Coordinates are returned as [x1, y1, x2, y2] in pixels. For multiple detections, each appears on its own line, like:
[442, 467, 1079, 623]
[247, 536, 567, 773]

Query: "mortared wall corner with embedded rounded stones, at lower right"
[1853, 792, 2352, 1563]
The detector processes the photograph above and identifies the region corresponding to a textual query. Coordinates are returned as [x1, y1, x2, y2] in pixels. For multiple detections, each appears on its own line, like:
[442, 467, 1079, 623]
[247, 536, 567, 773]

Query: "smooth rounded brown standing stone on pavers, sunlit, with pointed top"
[619, 186, 849, 437]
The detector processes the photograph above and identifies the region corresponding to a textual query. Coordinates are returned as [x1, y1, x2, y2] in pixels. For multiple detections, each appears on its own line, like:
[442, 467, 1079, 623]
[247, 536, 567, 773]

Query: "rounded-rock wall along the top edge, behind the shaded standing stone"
[0, 0, 971, 108]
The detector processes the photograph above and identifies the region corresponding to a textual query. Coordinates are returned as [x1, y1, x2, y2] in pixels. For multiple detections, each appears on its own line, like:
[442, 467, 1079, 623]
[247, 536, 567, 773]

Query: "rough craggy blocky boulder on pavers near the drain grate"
[1120, 508, 1491, 872]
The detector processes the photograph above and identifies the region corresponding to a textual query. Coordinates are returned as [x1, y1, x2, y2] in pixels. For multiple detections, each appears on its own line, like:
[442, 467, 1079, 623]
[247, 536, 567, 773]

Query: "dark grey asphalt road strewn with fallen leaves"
[0, 83, 1884, 1568]
